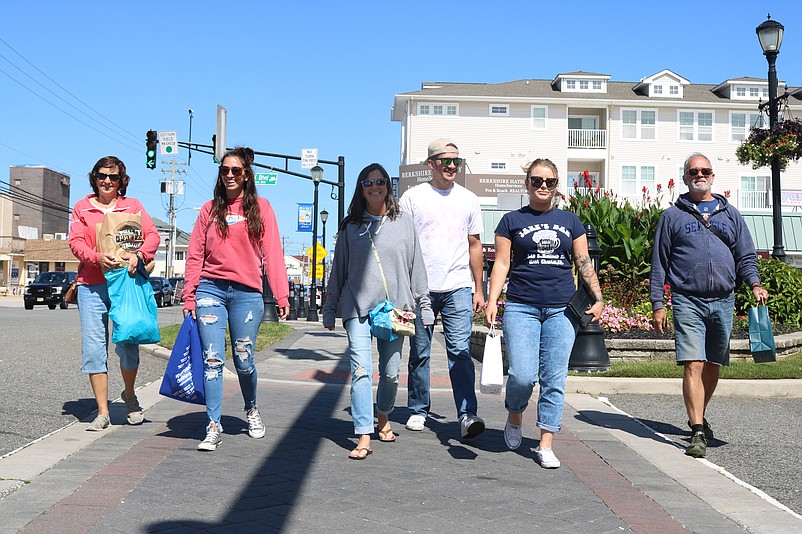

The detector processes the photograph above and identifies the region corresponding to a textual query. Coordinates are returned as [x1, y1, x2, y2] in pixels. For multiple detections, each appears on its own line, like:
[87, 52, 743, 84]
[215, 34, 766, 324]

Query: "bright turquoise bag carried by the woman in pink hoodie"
[105, 267, 161, 344]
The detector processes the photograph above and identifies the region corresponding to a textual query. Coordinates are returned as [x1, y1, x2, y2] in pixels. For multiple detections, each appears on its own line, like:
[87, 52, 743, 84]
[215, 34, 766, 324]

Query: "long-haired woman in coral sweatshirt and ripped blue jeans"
[182, 147, 290, 451]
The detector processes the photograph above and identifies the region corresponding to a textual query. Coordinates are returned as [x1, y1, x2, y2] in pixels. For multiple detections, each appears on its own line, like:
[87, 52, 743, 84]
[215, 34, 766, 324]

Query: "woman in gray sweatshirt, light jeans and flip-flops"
[323, 163, 434, 460]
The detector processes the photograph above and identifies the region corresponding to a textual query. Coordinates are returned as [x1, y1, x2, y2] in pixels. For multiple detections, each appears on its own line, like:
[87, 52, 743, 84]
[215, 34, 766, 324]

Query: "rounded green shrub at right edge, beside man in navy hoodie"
[735, 259, 802, 326]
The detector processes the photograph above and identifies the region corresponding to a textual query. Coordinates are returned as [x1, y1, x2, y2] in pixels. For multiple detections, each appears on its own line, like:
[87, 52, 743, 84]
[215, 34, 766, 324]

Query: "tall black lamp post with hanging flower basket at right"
[755, 15, 785, 261]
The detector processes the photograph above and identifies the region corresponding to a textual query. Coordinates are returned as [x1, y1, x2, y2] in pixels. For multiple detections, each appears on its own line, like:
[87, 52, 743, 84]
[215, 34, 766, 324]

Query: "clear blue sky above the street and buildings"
[0, 0, 802, 253]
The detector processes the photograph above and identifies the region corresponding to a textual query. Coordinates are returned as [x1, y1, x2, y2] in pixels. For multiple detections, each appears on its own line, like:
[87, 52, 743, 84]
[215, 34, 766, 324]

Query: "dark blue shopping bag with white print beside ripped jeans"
[159, 313, 206, 404]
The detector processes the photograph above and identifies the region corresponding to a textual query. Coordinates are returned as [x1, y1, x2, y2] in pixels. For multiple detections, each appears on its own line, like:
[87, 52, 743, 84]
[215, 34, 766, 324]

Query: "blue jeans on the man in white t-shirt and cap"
[407, 287, 477, 417]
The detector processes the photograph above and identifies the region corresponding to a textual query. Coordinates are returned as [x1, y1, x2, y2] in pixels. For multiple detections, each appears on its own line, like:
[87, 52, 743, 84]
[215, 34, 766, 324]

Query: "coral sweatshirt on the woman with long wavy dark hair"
[182, 197, 290, 310]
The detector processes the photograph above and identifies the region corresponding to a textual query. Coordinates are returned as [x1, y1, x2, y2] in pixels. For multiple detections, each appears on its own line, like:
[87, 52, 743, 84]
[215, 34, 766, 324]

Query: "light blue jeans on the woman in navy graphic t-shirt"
[503, 302, 577, 432]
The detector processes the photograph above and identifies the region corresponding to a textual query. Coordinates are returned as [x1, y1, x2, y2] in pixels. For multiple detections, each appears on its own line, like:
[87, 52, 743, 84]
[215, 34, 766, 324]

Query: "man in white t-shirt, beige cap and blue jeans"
[399, 139, 485, 438]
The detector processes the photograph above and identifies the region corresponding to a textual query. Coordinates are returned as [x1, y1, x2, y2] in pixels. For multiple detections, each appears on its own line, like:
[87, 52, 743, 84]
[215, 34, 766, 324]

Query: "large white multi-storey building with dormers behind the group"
[392, 70, 802, 264]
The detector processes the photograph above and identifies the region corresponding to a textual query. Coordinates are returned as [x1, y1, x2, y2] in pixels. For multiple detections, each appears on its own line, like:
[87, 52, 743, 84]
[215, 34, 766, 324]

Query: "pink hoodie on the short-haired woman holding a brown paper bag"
[68, 194, 160, 285]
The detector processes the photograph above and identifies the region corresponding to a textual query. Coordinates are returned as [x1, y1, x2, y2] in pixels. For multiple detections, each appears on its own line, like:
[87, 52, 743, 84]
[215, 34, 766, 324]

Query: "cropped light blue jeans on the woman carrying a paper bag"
[78, 284, 139, 374]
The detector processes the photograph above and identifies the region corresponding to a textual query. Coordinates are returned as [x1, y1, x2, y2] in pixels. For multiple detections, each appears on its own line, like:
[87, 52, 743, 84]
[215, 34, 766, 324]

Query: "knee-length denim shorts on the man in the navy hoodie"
[672, 292, 735, 366]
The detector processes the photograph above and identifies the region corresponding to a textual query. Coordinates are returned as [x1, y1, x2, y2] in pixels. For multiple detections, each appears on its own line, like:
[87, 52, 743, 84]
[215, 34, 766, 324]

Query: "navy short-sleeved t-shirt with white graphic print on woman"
[496, 206, 585, 308]
